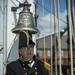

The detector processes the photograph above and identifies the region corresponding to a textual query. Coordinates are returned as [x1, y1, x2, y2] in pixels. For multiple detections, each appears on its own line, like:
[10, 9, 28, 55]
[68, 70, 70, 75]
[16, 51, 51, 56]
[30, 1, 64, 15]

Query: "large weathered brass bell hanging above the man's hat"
[12, 0, 38, 34]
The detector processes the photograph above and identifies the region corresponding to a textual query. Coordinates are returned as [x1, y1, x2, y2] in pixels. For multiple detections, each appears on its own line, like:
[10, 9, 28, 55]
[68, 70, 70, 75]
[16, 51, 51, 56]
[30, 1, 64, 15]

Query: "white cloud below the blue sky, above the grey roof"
[38, 10, 67, 35]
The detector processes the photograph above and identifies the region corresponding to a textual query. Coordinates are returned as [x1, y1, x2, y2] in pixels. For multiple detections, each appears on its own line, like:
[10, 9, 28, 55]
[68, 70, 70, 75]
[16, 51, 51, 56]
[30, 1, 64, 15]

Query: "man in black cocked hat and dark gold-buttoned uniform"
[6, 31, 49, 75]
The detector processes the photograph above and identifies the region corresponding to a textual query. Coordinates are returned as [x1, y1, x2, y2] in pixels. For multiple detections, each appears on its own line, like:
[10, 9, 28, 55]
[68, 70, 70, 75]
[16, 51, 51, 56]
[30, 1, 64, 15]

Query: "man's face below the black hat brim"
[19, 46, 34, 61]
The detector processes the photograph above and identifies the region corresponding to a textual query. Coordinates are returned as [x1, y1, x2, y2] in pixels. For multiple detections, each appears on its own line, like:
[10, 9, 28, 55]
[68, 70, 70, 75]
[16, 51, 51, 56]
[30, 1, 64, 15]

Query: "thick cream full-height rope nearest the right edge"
[68, 0, 73, 75]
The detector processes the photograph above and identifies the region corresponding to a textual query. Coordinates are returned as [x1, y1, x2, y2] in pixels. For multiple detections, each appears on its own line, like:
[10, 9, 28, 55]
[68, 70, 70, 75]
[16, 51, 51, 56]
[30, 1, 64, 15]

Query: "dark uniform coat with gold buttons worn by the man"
[6, 59, 49, 75]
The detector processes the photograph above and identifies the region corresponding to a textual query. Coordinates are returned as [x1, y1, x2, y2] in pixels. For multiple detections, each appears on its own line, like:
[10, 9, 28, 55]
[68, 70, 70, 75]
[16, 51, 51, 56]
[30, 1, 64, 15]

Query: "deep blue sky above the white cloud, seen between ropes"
[38, 0, 66, 13]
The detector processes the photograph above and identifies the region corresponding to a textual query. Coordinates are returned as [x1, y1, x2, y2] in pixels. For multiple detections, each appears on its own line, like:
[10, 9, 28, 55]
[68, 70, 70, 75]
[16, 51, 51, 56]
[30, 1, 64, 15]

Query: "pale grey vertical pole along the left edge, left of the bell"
[3, 0, 8, 75]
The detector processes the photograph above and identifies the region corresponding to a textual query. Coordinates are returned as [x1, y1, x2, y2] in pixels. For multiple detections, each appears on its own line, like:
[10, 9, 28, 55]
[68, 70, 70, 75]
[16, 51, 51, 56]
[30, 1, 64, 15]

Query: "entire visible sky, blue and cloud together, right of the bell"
[36, 0, 74, 35]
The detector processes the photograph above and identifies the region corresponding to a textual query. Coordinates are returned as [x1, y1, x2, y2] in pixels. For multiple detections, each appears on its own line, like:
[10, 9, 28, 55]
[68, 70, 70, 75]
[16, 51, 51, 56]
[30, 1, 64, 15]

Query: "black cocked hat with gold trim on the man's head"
[19, 31, 35, 49]
